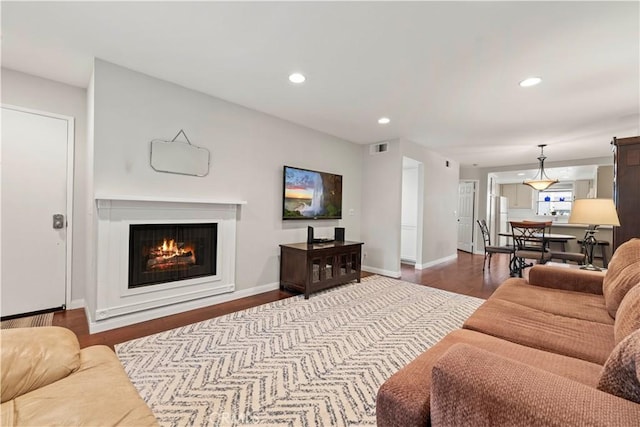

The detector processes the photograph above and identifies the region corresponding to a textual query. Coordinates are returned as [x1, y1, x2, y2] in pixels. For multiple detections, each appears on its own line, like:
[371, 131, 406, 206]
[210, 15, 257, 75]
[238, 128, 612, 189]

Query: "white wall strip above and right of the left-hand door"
[2, 68, 92, 308]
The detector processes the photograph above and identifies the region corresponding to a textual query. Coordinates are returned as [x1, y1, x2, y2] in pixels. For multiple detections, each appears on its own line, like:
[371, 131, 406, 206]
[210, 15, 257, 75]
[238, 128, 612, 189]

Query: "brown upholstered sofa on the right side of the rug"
[376, 239, 640, 427]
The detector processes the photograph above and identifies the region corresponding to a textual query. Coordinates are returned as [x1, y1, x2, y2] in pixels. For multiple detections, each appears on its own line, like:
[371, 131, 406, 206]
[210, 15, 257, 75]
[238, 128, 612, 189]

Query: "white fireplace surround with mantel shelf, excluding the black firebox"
[88, 196, 246, 333]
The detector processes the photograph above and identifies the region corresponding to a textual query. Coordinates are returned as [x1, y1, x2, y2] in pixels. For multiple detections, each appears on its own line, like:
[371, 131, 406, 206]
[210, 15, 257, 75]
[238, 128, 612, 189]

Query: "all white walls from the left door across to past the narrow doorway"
[2, 60, 458, 314]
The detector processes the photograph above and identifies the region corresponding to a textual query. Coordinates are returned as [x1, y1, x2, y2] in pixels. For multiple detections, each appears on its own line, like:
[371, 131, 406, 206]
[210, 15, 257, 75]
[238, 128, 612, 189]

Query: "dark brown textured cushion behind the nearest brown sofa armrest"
[598, 330, 640, 403]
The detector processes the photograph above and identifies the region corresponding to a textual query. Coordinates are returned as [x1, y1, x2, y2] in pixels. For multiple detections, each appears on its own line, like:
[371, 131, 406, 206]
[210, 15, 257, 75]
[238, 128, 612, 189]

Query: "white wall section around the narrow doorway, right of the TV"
[362, 140, 459, 276]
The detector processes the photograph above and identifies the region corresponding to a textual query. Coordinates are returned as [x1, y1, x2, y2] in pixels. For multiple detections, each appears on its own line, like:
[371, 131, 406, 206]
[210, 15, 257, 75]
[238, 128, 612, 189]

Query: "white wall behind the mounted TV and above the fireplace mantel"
[93, 60, 362, 290]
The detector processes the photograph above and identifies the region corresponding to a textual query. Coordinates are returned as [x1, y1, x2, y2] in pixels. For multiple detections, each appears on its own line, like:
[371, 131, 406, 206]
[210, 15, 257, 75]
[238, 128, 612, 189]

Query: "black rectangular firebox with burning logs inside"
[128, 223, 218, 289]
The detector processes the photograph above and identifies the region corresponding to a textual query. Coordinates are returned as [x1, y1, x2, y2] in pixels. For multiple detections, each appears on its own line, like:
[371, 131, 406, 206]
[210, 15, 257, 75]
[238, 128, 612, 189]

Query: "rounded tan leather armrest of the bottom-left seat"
[0, 326, 80, 402]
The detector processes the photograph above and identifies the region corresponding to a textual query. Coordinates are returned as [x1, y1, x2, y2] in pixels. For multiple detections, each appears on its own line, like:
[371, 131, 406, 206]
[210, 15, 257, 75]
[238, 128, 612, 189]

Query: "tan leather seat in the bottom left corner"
[0, 327, 158, 427]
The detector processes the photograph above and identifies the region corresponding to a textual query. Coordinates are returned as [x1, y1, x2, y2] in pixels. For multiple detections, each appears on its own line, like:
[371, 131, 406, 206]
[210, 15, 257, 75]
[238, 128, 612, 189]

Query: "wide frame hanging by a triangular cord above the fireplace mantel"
[150, 129, 211, 177]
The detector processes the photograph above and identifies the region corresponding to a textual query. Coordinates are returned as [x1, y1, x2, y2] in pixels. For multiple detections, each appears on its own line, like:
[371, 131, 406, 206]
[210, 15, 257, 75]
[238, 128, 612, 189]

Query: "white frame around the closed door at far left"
[0, 103, 75, 309]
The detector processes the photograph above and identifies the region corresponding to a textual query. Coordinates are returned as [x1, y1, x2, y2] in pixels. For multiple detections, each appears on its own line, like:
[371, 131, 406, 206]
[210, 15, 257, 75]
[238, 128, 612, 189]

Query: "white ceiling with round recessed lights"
[2, 1, 640, 167]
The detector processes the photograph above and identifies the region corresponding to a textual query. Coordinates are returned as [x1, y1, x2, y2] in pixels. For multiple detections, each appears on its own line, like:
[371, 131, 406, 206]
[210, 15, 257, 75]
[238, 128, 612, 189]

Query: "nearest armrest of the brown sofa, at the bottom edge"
[431, 344, 640, 426]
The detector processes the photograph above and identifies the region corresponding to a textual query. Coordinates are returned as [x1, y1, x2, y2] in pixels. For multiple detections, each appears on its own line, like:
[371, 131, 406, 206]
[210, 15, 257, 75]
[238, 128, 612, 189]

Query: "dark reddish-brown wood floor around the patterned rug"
[53, 251, 509, 348]
